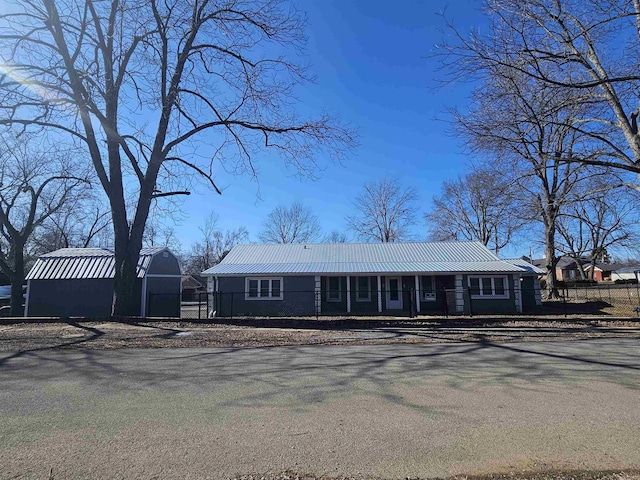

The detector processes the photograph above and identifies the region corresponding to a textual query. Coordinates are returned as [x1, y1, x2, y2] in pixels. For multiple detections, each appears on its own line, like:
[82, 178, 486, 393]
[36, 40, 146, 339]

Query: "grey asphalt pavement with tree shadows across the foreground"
[0, 339, 640, 478]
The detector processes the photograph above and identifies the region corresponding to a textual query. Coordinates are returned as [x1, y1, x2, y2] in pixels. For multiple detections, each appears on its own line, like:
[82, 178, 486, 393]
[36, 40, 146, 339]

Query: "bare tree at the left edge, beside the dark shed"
[0, 135, 89, 316]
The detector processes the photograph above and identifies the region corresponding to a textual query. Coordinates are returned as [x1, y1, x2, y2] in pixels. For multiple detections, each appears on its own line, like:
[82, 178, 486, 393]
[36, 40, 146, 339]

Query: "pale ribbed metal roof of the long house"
[202, 242, 523, 276]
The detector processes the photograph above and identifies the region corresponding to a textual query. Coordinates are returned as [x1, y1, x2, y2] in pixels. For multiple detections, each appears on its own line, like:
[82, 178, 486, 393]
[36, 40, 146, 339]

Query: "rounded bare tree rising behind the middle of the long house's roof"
[346, 177, 417, 242]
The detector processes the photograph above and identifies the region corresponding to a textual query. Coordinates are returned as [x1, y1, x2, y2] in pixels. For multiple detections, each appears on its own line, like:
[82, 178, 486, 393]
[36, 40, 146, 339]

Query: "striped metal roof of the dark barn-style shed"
[26, 247, 167, 280]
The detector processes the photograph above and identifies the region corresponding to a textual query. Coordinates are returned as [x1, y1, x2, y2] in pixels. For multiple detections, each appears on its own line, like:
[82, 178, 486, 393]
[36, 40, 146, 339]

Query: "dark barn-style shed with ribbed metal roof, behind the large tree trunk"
[25, 247, 182, 318]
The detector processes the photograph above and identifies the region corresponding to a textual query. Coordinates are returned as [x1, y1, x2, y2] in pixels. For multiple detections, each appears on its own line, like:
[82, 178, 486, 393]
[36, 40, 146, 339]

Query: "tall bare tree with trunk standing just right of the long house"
[453, 62, 601, 297]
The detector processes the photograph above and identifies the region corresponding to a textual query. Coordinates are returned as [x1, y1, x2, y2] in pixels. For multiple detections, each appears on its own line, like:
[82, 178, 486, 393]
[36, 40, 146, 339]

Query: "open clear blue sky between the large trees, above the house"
[172, 0, 508, 254]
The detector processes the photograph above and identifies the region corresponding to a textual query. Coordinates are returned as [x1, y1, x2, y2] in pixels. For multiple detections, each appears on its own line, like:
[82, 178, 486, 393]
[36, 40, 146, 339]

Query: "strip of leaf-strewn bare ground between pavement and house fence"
[0, 319, 640, 351]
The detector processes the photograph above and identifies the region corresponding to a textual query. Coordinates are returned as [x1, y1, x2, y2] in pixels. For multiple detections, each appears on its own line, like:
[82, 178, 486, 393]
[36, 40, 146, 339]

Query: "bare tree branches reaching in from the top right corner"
[443, 0, 640, 190]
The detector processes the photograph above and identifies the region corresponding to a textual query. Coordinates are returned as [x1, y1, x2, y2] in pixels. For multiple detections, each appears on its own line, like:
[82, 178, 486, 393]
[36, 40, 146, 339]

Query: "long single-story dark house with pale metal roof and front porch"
[202, 242, 539, 316]
